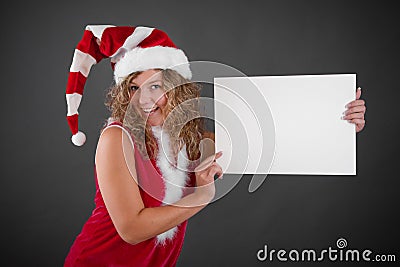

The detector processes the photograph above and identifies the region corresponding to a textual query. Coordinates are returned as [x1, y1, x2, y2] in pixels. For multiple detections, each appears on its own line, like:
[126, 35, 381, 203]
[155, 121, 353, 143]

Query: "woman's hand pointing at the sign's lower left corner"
[194, 151, 222, 204]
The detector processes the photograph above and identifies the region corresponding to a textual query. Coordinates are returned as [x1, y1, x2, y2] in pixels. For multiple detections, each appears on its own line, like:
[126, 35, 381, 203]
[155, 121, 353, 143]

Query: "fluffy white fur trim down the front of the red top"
[152, 126, 188, 245]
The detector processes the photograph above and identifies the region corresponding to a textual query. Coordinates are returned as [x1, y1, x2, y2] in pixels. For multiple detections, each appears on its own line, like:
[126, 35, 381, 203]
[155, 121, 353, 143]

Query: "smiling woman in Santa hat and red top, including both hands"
[64, 26, 365, 267]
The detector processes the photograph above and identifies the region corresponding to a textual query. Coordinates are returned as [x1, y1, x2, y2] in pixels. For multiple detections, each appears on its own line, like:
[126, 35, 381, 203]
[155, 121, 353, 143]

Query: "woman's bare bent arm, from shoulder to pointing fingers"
[96, 127, 222, 244]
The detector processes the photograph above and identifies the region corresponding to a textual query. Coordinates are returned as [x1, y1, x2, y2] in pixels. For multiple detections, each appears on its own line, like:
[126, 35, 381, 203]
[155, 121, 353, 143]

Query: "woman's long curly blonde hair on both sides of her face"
[105, 69, 205, 161]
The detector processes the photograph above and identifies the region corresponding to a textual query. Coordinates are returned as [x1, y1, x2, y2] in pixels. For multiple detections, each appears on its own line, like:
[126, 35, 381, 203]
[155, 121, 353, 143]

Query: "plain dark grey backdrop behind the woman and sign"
[0, 1, 400, 266]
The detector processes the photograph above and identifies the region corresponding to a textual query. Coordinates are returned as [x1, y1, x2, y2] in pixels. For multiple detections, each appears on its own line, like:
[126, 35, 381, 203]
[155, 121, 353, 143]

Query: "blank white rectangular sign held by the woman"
[214, 74, 356, 175]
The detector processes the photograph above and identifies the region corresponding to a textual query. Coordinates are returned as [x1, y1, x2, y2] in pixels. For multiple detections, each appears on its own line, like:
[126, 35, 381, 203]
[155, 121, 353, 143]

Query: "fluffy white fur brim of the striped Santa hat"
[114, 46, 192, 83]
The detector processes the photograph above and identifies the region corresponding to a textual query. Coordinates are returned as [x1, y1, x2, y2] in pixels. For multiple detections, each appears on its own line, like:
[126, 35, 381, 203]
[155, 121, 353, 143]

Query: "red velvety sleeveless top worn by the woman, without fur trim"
[64, 123, 194, 267]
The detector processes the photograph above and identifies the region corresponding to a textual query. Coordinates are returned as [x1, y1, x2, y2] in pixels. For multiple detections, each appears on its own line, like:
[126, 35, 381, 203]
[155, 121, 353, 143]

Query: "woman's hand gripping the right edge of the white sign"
[342, 87, 366, 133]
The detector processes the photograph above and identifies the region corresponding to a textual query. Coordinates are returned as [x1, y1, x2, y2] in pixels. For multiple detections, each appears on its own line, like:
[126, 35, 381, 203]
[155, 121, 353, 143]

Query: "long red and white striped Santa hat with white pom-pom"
[66, 25, 192, 146]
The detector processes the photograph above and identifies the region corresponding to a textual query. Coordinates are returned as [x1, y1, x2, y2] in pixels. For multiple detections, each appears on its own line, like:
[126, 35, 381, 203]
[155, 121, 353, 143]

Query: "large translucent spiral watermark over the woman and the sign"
[123, 61, 275, 207]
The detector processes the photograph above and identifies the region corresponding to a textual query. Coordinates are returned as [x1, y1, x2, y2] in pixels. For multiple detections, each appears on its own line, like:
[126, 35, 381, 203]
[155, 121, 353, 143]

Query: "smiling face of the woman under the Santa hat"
[130, 70, 167, 126]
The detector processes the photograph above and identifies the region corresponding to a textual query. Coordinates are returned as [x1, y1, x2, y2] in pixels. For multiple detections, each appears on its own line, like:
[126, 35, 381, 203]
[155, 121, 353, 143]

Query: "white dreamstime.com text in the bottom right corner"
[257, 238, 396, 262]
